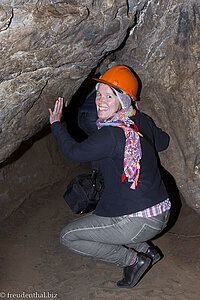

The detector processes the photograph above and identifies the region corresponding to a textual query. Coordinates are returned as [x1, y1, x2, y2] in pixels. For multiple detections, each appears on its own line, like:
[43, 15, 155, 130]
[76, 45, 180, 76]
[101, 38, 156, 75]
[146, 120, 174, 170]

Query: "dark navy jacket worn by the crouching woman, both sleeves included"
[51, 112, 169, 217]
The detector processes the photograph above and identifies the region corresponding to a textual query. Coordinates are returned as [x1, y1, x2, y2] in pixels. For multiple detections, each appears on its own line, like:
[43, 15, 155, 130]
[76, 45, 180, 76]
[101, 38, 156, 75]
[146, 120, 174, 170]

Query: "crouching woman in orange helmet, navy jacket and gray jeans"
[49, 65, 171, 288]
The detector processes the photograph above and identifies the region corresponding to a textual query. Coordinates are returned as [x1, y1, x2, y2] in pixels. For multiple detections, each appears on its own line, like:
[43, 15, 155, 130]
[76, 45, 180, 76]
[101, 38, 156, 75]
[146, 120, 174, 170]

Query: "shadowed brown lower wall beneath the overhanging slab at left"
[0, 128, 83, 221]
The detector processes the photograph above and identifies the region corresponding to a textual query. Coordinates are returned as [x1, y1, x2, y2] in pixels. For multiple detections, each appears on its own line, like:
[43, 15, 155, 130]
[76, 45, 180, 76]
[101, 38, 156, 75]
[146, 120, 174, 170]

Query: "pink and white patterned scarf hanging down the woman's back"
[96, 106, 142, 189]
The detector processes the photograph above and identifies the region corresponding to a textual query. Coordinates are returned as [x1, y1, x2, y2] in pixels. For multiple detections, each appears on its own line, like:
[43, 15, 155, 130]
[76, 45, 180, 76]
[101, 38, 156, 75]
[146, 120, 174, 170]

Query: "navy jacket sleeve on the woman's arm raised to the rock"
[51, 122, 116, 162]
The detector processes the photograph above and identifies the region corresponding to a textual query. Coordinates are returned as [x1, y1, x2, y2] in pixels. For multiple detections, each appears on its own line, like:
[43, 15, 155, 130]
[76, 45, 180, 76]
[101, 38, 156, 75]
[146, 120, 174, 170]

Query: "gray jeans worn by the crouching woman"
[60, 210, 169, 267]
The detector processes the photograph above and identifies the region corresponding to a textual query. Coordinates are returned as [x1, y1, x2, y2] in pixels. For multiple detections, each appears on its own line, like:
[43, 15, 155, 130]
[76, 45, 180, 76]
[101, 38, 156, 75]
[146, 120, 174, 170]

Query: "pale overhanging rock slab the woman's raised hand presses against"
[0, 0, 134, 161]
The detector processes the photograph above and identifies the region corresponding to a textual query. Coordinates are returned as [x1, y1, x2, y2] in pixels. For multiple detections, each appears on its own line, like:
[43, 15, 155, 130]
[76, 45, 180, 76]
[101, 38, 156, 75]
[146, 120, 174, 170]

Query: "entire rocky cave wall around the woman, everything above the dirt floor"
[0, 0, 200, 218]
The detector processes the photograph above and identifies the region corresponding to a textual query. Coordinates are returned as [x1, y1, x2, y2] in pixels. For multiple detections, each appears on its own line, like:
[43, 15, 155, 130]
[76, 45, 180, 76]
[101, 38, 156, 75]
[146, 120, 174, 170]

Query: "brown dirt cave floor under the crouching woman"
[0, 164, 200, 300]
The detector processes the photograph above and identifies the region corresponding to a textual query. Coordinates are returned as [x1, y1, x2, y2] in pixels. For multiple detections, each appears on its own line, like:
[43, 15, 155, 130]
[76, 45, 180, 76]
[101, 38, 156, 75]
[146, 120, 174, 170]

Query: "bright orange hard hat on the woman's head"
[94, 65, 138, 100]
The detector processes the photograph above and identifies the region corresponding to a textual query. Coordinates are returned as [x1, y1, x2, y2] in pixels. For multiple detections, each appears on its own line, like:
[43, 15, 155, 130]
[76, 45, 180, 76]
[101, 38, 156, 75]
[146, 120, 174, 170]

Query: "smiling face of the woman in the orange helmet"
[96, 83, 121, 120]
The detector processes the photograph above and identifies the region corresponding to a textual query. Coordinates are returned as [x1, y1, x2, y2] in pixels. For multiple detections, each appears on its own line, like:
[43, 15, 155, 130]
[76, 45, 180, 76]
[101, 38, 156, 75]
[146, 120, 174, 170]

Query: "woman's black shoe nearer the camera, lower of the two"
[117, 252, 152, 288]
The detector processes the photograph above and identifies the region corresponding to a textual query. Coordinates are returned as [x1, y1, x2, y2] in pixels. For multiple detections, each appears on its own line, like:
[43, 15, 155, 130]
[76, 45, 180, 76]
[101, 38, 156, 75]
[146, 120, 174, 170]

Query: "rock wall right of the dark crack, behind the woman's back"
[112, 1, 200, 212]
